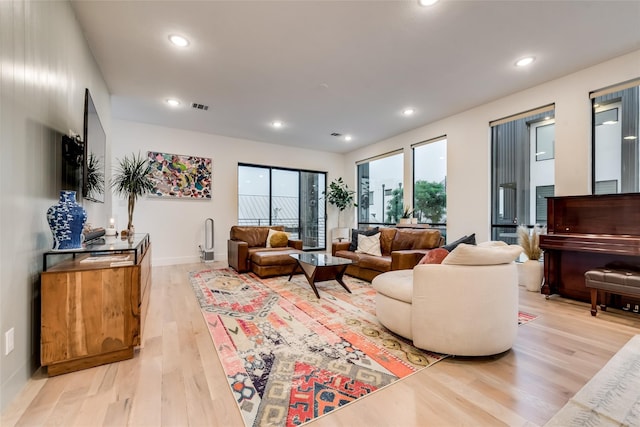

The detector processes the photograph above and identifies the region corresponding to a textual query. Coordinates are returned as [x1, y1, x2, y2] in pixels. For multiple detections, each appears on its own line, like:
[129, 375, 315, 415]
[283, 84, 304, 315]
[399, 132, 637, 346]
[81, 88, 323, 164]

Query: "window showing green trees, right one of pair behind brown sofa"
[413, 137, 447, 235]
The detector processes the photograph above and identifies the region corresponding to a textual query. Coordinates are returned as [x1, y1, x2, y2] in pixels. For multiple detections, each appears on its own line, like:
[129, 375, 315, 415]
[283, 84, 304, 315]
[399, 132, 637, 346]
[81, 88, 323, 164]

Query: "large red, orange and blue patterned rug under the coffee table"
[189, 269, 446, 426]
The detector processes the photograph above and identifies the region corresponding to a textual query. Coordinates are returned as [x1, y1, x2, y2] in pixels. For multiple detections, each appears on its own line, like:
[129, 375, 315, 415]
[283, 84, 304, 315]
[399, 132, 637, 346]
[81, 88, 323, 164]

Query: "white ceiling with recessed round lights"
[72, 0, 640, 153]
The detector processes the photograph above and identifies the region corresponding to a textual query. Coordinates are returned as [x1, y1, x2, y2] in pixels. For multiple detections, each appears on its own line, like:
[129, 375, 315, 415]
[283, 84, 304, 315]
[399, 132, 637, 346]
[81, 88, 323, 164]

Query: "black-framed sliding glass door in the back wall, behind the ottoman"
[238, 164, 326, 250]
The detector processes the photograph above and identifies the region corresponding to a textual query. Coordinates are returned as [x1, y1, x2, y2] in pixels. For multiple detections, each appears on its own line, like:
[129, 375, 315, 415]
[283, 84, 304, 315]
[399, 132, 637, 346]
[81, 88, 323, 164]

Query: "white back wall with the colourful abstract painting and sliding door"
[112, 119, 344, 265]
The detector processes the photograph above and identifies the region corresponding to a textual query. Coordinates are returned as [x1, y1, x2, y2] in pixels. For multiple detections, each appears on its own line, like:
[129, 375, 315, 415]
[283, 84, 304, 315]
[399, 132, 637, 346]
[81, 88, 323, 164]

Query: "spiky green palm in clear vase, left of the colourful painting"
[111, 153, 155, 233]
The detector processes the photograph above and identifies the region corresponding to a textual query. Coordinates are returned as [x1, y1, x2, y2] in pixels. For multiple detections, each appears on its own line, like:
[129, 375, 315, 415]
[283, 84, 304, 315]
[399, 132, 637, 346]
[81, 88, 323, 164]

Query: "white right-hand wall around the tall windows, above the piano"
[345, 50, 640, 241]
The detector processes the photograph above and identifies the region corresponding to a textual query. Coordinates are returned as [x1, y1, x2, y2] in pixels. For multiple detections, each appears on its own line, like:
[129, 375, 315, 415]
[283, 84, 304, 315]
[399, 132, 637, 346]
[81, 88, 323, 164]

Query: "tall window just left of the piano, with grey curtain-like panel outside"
[491, 105, 555, 243]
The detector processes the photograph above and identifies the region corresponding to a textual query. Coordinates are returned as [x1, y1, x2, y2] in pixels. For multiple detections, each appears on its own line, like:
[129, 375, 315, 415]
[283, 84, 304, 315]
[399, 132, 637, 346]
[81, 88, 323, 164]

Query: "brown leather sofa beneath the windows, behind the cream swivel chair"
[331, 228, 444, 282]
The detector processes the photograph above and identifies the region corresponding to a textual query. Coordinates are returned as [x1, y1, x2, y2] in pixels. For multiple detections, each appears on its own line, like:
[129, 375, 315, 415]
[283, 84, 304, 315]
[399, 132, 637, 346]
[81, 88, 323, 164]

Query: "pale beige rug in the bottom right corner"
[546, 335, 640, 427]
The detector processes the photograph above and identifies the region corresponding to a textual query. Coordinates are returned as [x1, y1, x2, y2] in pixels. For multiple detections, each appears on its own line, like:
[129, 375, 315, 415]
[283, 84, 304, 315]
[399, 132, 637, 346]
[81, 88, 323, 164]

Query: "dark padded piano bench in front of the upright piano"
[584, 268, 640, 316]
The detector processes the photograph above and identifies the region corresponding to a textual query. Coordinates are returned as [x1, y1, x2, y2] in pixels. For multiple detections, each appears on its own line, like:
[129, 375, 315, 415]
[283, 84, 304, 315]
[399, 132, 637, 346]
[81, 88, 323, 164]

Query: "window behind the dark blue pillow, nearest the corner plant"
[358, 151, 404, 227]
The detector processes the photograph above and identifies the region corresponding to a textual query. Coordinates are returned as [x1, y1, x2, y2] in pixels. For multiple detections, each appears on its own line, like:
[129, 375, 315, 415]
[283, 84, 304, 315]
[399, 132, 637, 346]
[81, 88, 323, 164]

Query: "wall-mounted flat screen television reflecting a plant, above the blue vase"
[82, 89, 107, 203]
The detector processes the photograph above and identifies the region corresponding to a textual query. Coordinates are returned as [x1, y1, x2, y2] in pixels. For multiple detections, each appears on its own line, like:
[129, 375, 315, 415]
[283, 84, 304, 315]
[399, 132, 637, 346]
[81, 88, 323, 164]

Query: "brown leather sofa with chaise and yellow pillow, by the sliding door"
[227, 225, 302, 277]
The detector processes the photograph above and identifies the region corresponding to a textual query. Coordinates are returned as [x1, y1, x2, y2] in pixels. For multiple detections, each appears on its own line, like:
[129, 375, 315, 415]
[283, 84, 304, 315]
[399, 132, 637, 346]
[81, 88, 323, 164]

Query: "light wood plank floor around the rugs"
[2, 263, 640, 427]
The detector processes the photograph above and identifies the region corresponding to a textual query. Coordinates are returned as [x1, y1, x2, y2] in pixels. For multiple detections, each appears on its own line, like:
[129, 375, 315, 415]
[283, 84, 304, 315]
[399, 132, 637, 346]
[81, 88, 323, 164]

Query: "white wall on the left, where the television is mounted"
[0, 1, 110, 409]
